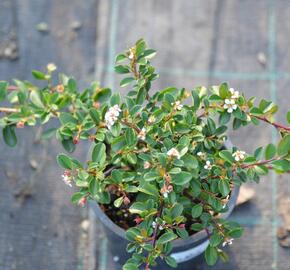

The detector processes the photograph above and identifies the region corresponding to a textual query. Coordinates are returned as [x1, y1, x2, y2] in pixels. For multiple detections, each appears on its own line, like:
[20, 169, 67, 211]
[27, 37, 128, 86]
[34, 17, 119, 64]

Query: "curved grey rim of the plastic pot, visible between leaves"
[89, 140, 240, 247]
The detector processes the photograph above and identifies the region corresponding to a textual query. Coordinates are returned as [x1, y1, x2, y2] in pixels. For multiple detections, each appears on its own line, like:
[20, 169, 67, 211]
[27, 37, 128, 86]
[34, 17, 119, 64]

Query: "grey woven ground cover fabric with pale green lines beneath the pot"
[0, 0, 290, 270]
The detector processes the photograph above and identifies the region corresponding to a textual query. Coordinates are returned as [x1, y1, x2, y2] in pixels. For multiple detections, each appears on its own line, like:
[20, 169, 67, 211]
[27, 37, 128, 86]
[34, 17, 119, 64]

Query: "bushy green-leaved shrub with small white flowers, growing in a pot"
[0, 39, 290, 270]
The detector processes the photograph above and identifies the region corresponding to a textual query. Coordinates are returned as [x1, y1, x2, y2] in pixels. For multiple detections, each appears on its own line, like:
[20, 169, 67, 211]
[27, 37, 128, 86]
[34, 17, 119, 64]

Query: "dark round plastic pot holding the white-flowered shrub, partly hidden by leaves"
[90, 142, 239, 270]
